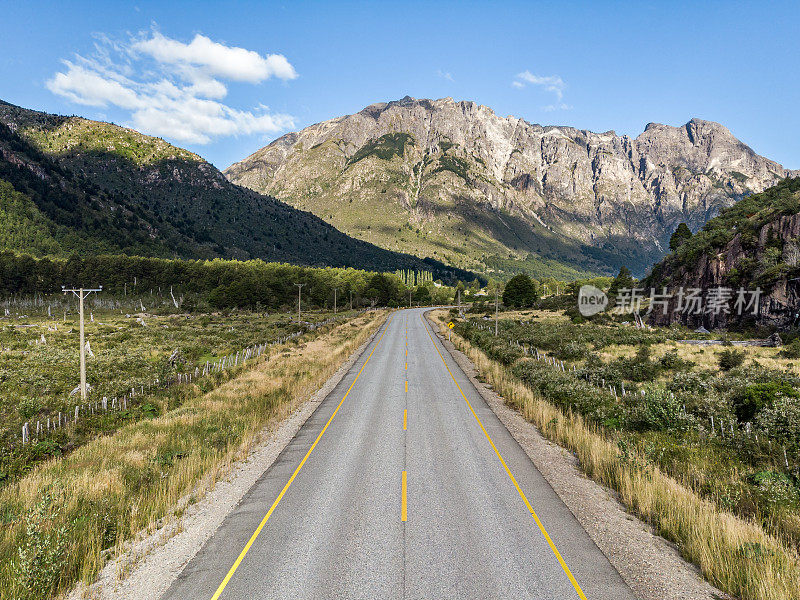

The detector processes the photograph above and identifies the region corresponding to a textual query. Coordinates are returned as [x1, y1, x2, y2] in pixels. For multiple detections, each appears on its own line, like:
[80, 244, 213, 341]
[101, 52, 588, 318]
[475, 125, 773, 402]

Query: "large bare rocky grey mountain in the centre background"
[225, 97, 790, 276]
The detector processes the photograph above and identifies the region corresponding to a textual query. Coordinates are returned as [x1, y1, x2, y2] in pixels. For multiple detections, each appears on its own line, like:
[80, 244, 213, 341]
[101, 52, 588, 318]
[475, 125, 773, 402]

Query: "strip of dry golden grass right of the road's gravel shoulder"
[434, 312, 800, 600]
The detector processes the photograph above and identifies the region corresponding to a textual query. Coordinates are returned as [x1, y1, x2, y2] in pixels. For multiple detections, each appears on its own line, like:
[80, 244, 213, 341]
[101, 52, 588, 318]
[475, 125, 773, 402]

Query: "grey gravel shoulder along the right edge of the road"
[426, 315, 732, 600]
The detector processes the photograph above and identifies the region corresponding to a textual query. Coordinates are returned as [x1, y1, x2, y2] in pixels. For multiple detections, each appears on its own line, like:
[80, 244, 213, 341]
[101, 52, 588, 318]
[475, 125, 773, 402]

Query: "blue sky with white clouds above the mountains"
[0, 0, 800, 168]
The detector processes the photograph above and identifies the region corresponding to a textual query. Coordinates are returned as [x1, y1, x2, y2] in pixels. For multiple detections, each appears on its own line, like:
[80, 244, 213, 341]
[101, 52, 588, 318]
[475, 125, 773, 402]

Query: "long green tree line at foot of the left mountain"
[0, 251, 452, 309]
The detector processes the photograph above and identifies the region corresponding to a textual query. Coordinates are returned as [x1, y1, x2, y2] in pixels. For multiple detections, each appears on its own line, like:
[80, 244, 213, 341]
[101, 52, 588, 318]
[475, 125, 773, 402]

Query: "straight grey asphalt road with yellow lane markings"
[162, 310, 634, 600]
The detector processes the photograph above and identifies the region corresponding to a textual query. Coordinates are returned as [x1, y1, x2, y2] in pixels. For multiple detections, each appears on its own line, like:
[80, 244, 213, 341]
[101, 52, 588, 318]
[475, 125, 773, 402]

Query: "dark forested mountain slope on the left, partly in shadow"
[0, 102, 471, 279]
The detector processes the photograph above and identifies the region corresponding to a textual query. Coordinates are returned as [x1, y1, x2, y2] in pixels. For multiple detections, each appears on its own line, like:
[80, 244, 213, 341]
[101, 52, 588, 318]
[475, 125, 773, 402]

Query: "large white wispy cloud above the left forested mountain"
[46, 32, 297, 144]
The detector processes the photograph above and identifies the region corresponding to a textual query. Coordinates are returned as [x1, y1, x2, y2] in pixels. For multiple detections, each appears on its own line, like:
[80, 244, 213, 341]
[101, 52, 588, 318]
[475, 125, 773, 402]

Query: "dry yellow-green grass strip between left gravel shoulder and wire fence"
[0, 312, 385, 600]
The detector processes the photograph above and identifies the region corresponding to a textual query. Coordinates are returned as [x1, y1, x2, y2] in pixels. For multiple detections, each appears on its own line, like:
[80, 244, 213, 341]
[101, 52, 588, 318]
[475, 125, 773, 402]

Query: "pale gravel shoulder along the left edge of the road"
[67, 327, 381, 600]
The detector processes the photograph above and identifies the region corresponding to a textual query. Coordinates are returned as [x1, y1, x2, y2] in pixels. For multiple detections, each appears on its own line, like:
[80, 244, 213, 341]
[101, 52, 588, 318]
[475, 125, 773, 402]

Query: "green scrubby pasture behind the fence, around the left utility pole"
[0, 308, 356, 485]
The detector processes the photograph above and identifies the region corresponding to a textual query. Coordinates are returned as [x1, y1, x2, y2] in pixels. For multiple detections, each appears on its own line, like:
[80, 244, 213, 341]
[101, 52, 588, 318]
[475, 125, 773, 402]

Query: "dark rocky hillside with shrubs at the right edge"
[644, 178, 800, 329]
